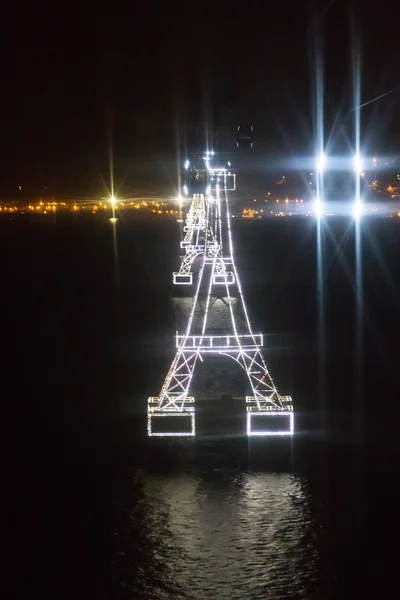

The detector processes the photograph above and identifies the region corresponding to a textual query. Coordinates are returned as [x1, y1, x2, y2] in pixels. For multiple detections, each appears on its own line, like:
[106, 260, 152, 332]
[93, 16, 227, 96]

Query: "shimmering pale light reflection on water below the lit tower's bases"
[108, 471, 317, 600]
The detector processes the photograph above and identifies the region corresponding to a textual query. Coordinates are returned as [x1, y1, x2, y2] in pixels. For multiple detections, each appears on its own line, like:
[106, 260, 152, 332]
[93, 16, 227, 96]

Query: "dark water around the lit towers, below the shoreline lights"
[0, 217, 400, 599]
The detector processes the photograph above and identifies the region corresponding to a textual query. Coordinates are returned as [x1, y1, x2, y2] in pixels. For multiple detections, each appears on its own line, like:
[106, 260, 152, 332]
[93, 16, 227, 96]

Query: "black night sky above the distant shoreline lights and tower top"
[0, 0, 400, 196]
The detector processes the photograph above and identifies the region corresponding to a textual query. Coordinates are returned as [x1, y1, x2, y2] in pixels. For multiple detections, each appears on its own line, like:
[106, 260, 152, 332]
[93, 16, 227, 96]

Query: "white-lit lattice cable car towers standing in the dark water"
[147, 158, 294, 436]
